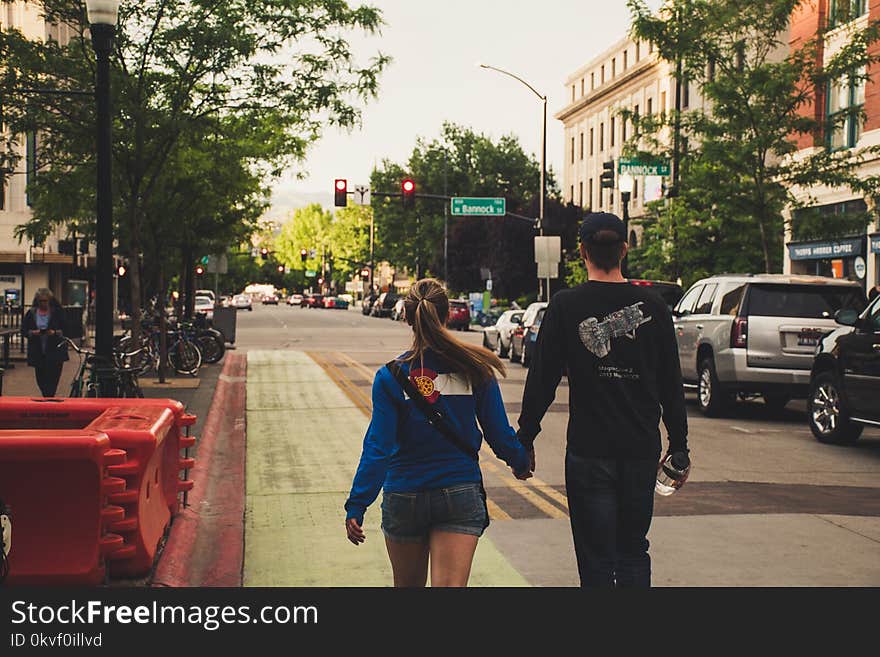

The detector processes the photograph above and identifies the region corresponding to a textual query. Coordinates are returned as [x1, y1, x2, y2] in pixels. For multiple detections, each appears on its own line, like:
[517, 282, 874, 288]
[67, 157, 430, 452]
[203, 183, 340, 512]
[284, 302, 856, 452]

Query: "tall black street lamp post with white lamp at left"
[86, 0, 119, 397]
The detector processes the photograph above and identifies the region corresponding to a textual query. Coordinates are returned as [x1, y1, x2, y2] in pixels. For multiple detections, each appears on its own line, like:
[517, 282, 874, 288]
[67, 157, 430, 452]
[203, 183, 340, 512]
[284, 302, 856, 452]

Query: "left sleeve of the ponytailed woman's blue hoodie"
[345, 367, 398, 524]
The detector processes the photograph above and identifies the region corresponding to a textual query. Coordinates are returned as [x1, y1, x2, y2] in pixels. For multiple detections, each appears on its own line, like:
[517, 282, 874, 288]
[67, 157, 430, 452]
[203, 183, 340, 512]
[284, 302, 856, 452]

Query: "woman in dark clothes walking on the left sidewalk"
[21, 287, 70, 397]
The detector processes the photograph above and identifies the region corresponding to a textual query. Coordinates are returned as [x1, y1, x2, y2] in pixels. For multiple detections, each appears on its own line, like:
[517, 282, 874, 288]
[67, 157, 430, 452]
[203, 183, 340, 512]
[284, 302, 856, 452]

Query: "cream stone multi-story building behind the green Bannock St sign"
[555, 38, 702, 246]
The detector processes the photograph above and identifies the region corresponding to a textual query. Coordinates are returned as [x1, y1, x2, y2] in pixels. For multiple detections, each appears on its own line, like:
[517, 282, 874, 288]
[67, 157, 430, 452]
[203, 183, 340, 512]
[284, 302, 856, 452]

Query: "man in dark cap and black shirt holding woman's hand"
[518, 212, 689, 587]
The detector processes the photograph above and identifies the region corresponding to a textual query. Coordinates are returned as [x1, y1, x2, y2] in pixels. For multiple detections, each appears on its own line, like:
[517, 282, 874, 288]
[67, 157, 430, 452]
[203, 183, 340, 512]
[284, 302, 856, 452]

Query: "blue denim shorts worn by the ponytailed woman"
[382, 482, 489, 543]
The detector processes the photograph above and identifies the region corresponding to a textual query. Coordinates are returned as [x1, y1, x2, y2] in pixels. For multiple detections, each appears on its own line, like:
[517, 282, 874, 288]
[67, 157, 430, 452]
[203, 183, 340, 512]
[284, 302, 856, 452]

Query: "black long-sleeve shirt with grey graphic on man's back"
[519, 281, 687, 458]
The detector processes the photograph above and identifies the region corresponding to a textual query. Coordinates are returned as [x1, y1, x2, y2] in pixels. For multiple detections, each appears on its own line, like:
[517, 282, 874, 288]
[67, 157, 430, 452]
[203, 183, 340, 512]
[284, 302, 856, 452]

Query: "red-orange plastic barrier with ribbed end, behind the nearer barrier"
[0, 397, 196, 583]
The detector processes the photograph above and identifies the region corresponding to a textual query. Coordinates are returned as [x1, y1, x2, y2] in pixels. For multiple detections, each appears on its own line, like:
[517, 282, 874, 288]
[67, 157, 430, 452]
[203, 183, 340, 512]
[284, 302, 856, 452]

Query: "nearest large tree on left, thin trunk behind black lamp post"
[0, 0, 389, 326]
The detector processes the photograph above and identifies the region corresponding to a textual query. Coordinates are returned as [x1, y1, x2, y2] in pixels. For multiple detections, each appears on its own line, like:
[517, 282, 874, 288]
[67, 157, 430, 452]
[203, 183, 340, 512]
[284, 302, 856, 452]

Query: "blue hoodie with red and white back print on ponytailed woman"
[345, 350, 529, 524]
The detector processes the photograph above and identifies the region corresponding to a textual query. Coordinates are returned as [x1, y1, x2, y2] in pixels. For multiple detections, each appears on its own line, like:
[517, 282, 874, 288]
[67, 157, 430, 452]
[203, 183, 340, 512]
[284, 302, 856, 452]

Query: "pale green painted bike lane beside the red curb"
[243, 350, 529, 587]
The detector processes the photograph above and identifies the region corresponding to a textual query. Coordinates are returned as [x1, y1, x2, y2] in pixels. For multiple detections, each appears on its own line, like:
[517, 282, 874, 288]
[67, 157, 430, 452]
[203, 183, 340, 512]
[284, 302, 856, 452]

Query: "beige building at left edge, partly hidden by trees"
[0, 0, 89, 318]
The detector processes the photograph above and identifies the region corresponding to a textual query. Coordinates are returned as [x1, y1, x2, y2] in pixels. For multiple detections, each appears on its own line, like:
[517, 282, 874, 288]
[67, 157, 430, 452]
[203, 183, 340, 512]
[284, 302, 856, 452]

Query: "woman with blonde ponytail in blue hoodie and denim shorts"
[345, 279, 532, 587]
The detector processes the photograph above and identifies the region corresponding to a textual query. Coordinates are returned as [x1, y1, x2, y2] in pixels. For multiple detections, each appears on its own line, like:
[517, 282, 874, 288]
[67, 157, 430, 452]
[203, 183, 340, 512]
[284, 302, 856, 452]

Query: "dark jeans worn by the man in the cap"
[565, 452, 657, 587]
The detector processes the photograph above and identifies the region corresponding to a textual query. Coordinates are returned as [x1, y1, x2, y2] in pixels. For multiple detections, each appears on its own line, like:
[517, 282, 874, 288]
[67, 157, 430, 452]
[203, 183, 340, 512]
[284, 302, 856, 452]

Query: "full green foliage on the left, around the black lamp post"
[0, 0, 389, 307]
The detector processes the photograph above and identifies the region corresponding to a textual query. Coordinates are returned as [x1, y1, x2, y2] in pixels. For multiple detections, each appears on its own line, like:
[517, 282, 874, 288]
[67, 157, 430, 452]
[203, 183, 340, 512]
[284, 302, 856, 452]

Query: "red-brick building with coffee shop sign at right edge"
[784, 0, 880, 287]
